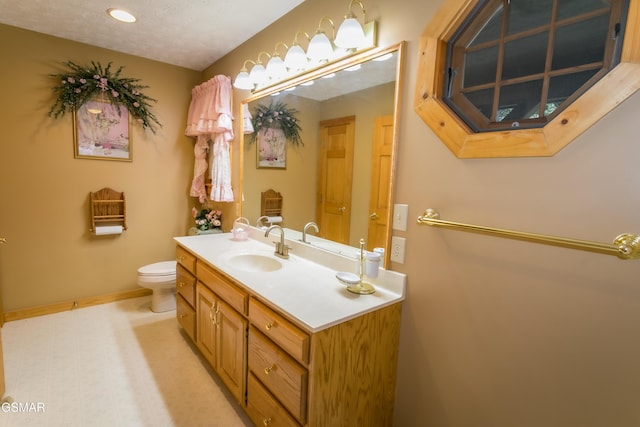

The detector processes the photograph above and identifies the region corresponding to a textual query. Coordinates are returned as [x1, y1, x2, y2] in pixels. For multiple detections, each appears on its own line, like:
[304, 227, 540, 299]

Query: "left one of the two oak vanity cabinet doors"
[196, 282, 219, 369]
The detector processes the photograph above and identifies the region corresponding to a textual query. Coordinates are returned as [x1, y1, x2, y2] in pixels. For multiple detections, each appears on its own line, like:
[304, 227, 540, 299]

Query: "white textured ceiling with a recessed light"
[0, 0, 303, 71]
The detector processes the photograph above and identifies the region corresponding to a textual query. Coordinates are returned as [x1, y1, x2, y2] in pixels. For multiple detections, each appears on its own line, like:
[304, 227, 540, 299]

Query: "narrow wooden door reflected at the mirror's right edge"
[367, 116, 393, 251]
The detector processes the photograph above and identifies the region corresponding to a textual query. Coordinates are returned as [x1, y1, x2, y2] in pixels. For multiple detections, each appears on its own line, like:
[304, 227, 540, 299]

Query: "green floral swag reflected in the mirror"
[249, 101, 304, 145]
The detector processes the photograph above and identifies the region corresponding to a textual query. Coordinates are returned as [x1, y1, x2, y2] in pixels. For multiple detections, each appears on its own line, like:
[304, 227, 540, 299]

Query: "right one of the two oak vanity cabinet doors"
[216, 301, 247, 403]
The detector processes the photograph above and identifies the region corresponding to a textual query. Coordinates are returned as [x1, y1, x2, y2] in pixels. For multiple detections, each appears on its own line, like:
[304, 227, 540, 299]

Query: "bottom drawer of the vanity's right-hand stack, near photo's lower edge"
[247, 374, 300, 427]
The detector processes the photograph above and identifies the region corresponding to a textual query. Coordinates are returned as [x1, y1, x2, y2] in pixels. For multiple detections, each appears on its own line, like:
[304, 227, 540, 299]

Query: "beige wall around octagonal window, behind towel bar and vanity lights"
[205, 0, 640, 427]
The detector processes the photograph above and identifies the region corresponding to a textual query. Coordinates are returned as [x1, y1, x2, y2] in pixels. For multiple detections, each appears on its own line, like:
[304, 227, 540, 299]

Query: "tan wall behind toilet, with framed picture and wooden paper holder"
[0, 25, 202, 311]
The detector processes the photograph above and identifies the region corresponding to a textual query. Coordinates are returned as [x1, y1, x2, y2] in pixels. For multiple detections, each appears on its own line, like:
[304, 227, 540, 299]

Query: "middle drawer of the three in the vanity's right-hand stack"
[249, 327, 308, 423]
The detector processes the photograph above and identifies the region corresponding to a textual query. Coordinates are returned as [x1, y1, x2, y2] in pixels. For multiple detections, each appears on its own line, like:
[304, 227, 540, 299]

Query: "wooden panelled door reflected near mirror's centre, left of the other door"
[316, 116, 356, 244]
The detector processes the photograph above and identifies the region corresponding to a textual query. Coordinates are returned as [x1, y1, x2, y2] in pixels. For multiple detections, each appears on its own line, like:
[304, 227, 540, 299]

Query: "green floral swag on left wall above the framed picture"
[49, 61, 162, 133]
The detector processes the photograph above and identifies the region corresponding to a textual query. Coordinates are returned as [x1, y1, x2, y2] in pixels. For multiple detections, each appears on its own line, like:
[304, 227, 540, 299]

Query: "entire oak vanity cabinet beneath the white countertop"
[177, 247, 401, 427]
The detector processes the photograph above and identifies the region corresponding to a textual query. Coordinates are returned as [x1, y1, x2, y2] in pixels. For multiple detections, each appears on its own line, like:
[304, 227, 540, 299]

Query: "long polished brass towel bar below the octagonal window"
[418, 209, 640, 259]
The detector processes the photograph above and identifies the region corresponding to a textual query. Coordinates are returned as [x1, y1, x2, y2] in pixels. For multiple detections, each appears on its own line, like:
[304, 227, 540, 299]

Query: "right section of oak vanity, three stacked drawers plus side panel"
[247, 297, 401, 427]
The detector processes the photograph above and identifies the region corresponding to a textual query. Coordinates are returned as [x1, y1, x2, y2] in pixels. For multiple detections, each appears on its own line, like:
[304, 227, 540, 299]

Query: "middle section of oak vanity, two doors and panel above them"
[196, 262, 248, 405]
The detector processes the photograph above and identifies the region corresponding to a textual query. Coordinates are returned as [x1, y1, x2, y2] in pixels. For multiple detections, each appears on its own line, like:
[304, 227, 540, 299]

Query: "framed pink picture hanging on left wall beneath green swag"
[73, 100, 133, 162]
